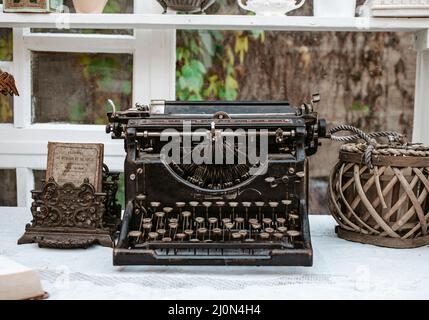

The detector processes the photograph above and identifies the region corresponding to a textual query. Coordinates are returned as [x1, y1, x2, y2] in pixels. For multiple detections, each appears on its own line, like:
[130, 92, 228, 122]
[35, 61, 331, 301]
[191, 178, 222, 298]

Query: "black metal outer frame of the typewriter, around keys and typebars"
[107, 102, 325, 266]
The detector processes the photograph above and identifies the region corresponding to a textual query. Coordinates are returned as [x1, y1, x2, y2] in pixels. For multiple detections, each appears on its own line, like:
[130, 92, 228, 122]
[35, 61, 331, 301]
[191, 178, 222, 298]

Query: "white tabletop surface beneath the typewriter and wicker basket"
[0, 209, 429, 299]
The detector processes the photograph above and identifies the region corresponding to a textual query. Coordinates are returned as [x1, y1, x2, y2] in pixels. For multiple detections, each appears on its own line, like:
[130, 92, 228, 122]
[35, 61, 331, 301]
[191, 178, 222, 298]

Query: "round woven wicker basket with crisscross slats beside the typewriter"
[329, 127, 429, 248]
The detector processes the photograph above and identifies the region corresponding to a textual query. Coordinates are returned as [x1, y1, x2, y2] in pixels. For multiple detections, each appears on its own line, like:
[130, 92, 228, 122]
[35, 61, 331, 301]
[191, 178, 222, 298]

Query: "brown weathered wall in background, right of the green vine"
[201, 0, 416, 212]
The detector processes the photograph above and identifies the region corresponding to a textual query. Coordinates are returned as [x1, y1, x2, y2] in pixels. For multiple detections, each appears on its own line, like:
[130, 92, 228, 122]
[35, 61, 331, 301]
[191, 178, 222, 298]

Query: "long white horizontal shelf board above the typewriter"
[0, 13, 429, 32]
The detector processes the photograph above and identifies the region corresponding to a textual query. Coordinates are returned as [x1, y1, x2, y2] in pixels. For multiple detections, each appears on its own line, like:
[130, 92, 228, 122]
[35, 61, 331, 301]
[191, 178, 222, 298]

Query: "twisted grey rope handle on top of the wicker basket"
[328, 125, 404, 171]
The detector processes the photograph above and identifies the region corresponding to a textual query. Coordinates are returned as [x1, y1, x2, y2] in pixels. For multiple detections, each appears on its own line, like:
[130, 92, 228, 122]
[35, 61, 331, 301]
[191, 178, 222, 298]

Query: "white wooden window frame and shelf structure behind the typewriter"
[0, 1, 429, 207]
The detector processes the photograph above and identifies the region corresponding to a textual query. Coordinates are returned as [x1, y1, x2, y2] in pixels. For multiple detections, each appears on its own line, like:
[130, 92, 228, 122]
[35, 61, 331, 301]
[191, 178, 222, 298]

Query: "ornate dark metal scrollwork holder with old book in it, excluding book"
[18, 166, 121, 249]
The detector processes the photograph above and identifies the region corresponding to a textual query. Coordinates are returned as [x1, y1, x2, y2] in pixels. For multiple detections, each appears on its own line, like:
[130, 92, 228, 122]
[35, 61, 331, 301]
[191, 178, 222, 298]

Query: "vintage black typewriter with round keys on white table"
[106, 95, 325, 266]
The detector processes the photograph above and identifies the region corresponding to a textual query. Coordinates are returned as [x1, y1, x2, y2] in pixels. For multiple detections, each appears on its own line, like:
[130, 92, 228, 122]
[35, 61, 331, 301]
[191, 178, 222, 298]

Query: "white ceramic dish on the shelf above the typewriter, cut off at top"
[237, 0, 305, 16]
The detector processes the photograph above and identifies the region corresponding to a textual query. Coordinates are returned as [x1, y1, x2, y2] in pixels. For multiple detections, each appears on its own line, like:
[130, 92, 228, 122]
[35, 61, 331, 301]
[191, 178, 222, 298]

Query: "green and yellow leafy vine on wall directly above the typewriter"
[176, 26, 265, 101]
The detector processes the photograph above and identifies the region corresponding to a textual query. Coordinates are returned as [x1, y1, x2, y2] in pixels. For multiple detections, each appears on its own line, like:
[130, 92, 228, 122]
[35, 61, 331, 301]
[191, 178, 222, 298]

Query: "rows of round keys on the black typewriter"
[128, 200, 302, 245]
